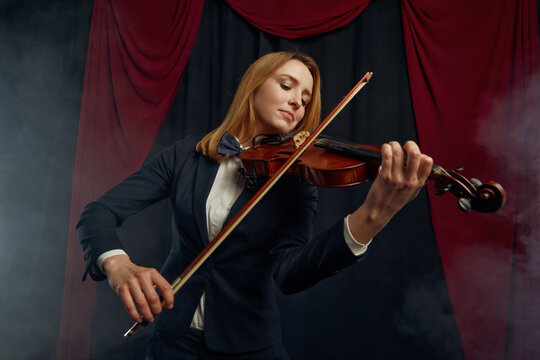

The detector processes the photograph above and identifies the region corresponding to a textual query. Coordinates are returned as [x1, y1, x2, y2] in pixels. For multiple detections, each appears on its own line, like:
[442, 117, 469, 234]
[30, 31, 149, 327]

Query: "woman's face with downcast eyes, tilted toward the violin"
[253, 60, 313, 136]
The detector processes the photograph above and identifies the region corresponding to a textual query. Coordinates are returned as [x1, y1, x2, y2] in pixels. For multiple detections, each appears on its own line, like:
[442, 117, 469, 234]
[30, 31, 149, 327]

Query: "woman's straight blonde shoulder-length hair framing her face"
[196, 51, 321, 162]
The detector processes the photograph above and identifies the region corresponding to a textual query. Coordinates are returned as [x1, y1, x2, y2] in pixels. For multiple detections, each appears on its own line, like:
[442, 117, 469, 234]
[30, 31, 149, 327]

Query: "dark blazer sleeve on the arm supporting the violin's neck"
[270, 181, 366, 294]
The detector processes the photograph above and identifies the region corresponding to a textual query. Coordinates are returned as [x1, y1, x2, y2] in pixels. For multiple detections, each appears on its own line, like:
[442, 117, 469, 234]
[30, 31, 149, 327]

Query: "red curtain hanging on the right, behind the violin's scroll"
[402, 0, 540, 359]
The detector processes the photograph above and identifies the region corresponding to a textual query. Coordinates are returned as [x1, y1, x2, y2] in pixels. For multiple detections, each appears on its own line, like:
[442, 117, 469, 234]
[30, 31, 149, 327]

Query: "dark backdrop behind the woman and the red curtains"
[0, 0, 502, 359]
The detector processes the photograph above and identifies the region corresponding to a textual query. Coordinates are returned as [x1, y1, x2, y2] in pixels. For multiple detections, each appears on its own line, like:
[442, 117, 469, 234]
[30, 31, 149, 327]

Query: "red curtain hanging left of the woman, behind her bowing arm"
[57, 0, 204, 359]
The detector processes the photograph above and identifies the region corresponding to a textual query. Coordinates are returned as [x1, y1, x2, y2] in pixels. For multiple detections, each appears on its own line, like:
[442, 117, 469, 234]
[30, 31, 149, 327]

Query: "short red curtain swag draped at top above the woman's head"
[226, 0, 371, 39]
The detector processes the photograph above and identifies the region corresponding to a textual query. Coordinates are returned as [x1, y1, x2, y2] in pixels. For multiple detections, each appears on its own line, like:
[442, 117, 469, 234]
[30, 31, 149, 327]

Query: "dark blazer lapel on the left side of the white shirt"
[193, 155, 219, 245]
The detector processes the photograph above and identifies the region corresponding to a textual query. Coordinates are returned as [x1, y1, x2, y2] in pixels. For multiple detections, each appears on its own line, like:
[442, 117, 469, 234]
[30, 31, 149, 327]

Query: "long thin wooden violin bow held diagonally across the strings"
[124, 72, 373, 337]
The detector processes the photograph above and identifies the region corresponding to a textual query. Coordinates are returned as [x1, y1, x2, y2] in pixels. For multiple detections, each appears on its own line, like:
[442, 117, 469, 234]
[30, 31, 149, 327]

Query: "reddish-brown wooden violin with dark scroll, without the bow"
[239, 133, 506, 213]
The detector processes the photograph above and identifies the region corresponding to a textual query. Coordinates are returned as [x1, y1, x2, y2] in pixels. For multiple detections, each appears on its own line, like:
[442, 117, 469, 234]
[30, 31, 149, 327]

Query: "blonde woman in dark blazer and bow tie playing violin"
[77, 52, 432, 359]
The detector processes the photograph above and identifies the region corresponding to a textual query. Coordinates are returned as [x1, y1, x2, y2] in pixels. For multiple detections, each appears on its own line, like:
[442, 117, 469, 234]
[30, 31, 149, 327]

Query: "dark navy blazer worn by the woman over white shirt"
[77, 138, 358, 353]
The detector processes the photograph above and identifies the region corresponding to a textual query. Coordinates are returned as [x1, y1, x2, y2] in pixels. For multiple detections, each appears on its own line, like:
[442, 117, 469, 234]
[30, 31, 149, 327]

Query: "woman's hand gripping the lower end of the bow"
[103, 255, 174, 323]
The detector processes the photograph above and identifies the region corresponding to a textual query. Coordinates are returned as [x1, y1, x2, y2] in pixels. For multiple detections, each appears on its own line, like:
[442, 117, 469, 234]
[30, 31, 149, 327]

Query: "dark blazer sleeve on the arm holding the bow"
[77, 136, 194, 280]
